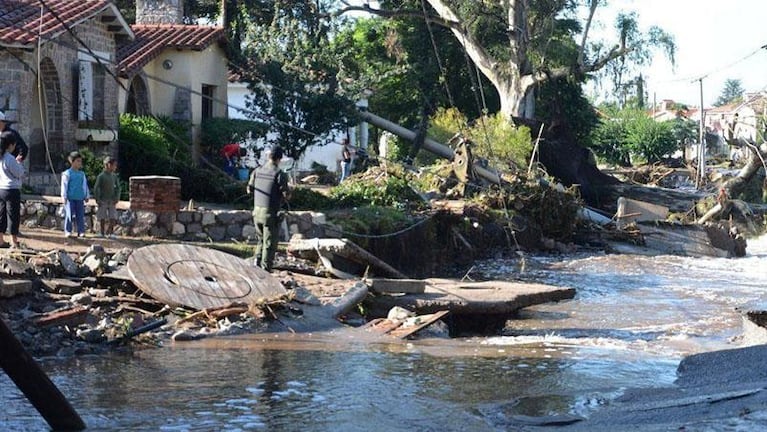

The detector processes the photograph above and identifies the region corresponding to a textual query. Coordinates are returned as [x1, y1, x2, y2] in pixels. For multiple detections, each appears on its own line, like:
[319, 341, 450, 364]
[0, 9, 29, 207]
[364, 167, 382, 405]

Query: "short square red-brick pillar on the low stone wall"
[130, 176, 181, 213]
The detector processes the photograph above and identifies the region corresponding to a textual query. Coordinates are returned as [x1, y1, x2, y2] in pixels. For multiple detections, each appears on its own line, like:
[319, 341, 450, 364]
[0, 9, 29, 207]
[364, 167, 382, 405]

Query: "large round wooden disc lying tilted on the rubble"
[127, 243, 287, 310]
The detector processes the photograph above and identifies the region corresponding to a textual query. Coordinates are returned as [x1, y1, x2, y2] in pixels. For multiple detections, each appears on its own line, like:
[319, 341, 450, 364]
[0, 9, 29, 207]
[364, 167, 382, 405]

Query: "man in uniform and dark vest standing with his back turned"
[247, 147, 290, 271]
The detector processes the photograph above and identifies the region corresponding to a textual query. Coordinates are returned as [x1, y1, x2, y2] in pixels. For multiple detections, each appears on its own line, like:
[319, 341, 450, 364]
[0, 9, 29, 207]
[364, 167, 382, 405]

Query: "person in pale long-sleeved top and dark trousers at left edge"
[0, 131, 24, 248]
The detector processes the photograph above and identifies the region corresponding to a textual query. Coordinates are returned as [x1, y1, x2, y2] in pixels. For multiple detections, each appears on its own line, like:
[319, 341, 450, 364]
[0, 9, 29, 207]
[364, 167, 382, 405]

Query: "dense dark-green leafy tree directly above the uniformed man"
[238, 0, 356, 159]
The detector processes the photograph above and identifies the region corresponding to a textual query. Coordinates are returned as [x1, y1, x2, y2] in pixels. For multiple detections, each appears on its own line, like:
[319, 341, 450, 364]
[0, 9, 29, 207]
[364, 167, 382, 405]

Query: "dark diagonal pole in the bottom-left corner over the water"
[0, 319, 85, 431]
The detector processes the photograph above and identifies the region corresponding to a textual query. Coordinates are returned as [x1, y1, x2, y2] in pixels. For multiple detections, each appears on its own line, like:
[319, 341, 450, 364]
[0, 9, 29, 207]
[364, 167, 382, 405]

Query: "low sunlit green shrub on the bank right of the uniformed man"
[330, 167, 424, 210]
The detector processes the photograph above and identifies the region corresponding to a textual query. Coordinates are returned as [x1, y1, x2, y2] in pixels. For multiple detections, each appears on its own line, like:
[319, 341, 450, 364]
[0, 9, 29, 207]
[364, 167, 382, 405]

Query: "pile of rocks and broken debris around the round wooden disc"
[0, 245, 304, 356]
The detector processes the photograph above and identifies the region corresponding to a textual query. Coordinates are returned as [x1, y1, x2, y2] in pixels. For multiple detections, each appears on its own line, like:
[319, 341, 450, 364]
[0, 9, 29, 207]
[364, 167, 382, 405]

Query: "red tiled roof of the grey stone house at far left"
[0, 0, 130, 48]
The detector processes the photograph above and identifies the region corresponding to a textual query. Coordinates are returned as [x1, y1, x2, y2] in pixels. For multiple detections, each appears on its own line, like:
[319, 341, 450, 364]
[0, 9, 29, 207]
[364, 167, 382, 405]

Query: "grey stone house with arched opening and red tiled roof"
[0, 0, 133, 176]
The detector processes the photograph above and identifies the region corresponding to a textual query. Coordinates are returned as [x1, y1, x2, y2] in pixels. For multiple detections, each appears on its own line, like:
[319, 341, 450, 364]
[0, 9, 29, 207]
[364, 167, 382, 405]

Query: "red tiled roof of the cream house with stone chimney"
[117, 24, 226, 76]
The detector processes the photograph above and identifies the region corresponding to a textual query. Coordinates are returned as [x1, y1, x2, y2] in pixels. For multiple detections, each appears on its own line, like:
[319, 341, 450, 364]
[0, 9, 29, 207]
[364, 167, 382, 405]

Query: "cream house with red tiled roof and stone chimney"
[117, 0, 228, 159]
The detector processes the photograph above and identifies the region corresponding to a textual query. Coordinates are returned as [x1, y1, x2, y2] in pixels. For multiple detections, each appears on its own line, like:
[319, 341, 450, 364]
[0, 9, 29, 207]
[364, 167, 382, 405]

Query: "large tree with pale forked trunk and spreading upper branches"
[339, 0, 675, 117]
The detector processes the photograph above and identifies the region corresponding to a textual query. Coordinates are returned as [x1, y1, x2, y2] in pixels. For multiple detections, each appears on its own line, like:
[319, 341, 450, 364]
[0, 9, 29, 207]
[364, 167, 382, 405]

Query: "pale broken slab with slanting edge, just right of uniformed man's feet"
[288, 238, 407, 279]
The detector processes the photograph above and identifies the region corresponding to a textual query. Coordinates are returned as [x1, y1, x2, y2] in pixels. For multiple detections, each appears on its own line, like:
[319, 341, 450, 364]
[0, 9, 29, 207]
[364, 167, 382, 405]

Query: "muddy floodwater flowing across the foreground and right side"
[0, 238, 767, 431]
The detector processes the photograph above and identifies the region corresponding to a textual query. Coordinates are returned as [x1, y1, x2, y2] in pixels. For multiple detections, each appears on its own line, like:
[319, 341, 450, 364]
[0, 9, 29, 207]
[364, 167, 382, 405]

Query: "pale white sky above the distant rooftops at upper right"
[598, 0, 767, 107]
